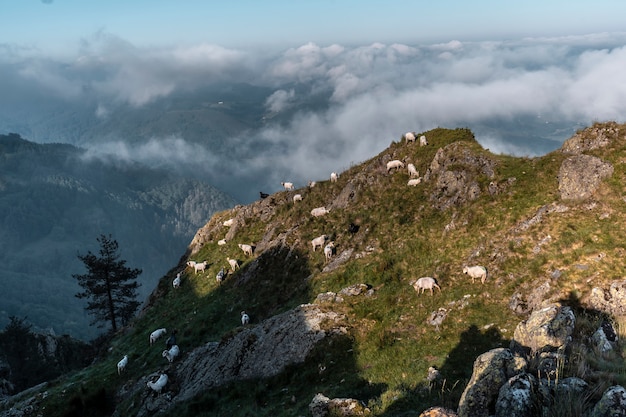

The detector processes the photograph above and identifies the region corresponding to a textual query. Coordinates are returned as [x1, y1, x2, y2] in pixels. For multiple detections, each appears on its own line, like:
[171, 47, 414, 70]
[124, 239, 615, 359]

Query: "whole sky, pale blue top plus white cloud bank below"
[0, 0, 626, 198]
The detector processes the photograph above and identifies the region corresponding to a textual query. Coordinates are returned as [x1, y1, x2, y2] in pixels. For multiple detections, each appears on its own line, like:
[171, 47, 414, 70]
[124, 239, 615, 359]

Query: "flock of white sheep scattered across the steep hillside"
[117, 132, 487, 393]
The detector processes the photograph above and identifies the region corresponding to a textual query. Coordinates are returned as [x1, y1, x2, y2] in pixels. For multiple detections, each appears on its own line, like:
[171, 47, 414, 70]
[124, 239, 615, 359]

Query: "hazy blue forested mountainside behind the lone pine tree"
[0, 134, 236, 340]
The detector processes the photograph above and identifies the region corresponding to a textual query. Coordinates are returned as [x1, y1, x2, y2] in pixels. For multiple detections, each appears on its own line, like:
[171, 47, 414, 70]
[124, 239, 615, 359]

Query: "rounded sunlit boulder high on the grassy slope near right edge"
[559, 155, 613, 200]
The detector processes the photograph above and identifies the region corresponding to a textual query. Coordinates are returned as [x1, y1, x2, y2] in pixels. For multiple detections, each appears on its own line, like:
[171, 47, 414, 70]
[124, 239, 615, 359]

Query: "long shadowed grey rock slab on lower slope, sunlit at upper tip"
[125, 304, 347, 416]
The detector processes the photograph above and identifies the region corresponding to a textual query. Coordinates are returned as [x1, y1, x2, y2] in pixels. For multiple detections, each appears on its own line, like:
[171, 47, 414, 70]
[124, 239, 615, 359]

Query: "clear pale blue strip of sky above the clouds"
[0, 0, 626, 52]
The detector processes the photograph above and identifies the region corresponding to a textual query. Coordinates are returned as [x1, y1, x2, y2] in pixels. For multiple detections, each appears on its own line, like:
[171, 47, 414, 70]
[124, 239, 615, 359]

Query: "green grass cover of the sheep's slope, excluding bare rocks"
[15, 122, 626, 416]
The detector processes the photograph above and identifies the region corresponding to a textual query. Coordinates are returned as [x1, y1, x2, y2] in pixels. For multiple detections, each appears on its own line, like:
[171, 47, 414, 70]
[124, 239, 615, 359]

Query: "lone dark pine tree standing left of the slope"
[72, 235, 142, 332]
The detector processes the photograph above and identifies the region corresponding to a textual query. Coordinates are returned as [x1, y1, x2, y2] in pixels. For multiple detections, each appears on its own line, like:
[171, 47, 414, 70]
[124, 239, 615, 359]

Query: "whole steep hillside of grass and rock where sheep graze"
[3, 123, 626, 416]
